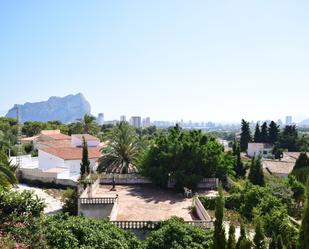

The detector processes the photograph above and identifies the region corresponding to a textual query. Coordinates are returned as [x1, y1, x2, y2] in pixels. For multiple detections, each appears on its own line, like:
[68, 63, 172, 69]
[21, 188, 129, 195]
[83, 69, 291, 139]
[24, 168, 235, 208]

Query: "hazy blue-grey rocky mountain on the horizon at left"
[6, 93, 91, 123]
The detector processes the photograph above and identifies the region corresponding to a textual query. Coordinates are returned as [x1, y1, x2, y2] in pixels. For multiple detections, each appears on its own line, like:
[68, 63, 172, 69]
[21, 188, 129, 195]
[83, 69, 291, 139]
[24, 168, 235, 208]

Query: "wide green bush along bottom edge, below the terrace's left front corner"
[46, 215, 141, 249]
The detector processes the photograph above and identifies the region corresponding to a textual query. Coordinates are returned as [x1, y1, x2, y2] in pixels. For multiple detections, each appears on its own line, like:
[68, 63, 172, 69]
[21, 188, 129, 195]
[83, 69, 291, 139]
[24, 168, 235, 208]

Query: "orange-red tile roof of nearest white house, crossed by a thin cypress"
[40, 147, 101, 160]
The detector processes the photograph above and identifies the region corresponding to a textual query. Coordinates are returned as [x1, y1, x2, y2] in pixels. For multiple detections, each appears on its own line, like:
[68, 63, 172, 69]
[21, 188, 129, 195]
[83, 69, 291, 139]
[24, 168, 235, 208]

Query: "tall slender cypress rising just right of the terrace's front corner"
[213, 188, 226, 249]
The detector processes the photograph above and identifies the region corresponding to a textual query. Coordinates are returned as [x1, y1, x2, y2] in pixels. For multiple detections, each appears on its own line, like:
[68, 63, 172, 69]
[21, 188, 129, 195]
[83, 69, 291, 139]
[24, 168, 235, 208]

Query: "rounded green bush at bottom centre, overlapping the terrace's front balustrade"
[145, 218, 212, 249]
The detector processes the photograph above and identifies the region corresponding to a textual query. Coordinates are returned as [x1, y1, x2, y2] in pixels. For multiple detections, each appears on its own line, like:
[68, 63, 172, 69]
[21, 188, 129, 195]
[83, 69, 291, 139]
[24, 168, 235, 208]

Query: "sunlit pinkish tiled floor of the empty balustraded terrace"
[94, 185, 194, 221]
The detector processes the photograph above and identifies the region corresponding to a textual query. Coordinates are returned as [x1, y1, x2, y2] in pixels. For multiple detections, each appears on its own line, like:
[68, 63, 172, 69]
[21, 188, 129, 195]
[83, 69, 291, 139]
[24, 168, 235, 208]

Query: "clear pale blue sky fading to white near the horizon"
[0, 0, 309, 122]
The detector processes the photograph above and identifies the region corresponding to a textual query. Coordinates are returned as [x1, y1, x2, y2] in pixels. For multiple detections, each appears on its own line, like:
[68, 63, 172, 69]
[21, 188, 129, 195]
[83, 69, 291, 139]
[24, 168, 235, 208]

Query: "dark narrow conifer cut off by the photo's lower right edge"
[298, 179, 309, 249]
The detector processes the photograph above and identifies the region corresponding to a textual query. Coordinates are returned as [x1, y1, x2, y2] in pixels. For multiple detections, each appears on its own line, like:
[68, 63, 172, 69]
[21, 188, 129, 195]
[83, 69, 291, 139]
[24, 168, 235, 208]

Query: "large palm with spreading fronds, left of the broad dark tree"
[97, 122, 140, 174]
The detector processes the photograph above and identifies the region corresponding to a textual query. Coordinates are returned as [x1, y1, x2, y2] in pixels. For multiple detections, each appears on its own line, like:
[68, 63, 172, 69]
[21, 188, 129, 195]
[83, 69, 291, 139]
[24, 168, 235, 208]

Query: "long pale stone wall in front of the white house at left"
[17, 168, 77, 187]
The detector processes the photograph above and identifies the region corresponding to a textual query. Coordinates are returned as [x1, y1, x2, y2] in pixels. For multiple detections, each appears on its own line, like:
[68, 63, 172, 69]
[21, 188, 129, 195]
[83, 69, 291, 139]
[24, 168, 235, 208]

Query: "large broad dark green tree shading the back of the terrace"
[141, 125, 230, 189]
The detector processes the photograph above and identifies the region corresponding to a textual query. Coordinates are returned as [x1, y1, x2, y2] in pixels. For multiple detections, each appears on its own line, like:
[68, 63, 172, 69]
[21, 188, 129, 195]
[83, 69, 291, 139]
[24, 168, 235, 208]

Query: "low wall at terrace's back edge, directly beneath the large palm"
[100, 174, 152, 185]
